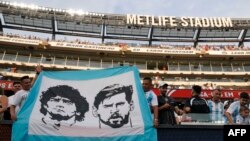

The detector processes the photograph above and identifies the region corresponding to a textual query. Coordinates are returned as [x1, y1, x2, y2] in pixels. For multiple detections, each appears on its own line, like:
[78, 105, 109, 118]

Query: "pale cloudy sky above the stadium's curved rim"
[6, 0, 250, 18]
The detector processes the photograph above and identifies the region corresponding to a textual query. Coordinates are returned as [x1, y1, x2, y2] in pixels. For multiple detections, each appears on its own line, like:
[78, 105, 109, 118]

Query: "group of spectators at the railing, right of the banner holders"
[150, 83, 250, 125]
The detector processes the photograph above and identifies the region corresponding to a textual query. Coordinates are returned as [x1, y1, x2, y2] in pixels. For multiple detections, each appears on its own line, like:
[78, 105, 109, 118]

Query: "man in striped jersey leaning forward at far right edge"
[225, 92, 249, 124]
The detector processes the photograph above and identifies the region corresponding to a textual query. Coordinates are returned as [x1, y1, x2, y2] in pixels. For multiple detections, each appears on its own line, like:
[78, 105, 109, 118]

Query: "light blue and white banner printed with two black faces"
[12, 67, 157, 141]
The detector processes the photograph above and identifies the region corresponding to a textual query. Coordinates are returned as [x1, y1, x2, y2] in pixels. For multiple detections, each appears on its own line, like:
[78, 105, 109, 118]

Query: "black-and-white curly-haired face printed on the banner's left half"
[40, 85, 89, 130]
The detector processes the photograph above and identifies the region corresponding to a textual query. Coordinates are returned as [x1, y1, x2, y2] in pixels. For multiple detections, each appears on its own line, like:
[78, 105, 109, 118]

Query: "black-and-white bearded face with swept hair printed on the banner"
[93, 84, 134, 128]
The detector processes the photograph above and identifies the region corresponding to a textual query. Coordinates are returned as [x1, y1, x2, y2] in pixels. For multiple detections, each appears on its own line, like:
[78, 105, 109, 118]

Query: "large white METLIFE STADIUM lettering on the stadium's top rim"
[127, 14, 233, 28]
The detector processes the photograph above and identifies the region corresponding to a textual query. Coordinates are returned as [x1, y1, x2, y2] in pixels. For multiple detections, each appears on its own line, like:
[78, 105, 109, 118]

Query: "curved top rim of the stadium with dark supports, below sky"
[0, 2, 250, 46]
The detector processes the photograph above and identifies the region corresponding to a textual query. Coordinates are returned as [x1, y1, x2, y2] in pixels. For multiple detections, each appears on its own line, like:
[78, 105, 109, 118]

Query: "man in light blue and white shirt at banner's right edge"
[142, 77, 159, 127]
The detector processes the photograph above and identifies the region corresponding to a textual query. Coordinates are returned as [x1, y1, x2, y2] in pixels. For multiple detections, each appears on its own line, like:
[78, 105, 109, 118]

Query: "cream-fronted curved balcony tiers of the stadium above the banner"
[0, 35, 250, 87]
